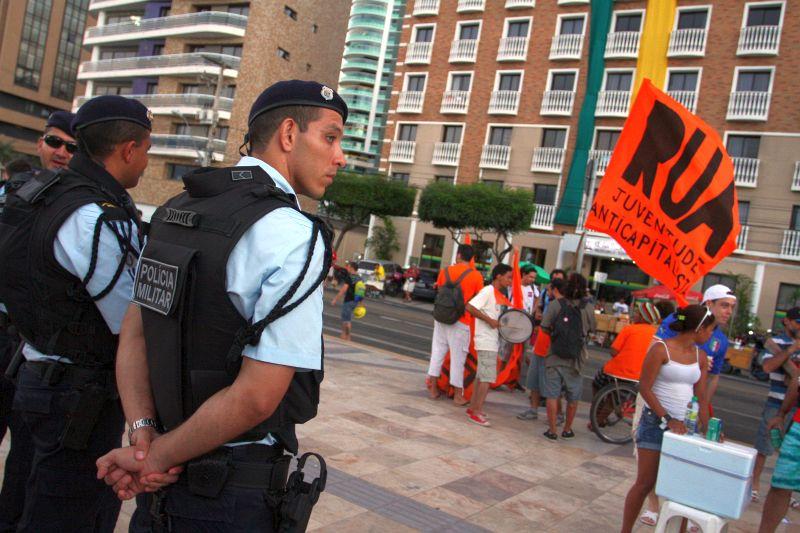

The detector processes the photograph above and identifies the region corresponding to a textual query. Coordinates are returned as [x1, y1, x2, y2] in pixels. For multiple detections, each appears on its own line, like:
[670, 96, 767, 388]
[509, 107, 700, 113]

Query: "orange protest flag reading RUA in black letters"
[585, 80, 740, 305]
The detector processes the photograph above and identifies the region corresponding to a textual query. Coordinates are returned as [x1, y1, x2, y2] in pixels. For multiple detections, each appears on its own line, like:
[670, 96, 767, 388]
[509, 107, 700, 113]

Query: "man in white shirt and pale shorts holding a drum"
[467, 263, 512, 427]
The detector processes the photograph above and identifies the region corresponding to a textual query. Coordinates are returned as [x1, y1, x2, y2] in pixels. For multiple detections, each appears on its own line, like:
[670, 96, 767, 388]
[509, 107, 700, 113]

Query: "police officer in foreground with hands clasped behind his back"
[98, 80, 347, 532]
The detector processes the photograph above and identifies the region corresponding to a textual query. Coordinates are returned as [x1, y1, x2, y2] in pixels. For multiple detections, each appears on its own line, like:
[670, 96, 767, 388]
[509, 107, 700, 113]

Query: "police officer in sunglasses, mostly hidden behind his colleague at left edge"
[0, 111, 78, 532]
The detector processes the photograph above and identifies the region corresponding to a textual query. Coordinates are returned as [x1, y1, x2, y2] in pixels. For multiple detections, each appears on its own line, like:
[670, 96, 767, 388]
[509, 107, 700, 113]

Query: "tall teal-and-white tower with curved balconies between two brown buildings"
[339, 0, 406, 171]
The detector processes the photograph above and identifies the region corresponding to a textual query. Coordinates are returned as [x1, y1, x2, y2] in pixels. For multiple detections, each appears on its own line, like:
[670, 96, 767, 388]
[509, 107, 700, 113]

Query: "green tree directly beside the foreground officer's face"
[320, 172, 416, 251]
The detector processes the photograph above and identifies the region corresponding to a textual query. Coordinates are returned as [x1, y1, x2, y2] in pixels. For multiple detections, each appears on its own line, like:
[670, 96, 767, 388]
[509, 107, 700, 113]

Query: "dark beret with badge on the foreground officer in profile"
[247, 80, 347, 126]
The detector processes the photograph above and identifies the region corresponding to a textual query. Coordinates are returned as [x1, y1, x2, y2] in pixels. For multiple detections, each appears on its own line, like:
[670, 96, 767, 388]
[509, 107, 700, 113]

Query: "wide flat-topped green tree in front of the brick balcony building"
[418, 183, 533, 262]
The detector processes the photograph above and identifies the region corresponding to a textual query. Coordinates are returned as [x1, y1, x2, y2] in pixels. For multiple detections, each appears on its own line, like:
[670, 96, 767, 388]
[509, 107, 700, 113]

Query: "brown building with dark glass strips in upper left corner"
[0, 0, 93, 155]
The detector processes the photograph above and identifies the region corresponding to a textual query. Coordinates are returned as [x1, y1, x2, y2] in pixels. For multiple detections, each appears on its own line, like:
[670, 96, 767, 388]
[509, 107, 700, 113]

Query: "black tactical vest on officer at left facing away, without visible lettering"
[0, 167, 136, 368]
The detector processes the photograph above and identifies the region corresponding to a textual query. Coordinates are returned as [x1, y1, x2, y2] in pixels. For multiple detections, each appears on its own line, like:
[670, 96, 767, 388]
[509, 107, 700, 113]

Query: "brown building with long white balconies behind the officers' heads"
[76, 0, 350, 214]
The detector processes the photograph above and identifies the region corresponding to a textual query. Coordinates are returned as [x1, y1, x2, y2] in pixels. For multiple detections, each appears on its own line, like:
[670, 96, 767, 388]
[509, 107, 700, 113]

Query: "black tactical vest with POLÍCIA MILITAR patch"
[134, 167, 330, 452]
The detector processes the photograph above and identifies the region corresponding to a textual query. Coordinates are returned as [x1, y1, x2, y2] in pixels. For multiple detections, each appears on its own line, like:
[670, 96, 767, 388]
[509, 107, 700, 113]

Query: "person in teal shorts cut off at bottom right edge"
[758, 382, 800, 533]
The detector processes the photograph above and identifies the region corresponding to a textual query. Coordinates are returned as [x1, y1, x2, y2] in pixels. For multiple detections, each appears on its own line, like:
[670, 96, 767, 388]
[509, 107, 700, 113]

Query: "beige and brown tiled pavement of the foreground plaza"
[0, 338, 800, 533]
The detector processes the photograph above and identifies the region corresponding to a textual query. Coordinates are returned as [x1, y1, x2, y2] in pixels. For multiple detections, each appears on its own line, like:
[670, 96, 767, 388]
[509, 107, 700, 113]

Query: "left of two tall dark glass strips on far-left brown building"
[14, 0, 52, 90]
